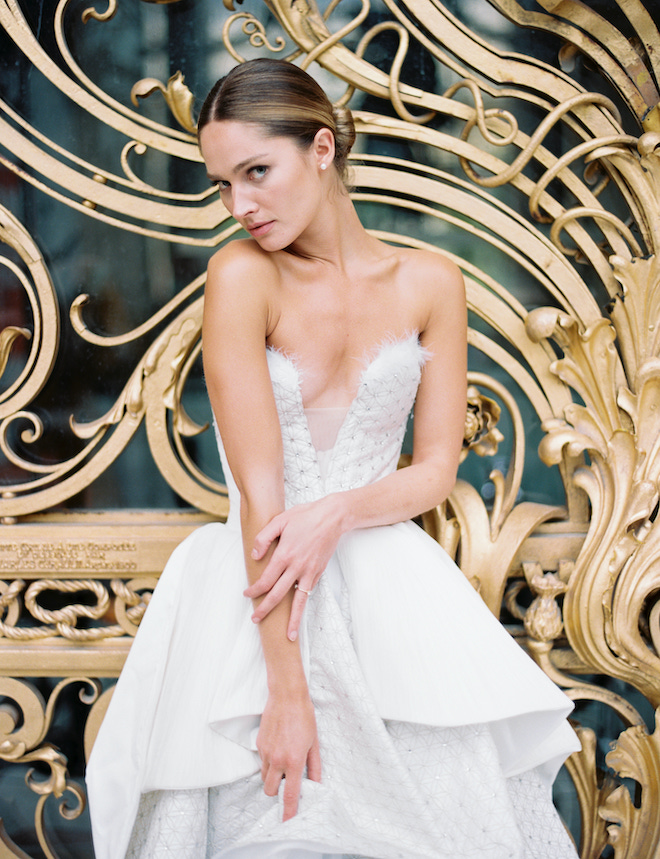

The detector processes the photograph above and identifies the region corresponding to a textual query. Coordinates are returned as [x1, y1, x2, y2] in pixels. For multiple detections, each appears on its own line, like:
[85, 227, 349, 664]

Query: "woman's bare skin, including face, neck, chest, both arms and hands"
[200, 121, 467, 820]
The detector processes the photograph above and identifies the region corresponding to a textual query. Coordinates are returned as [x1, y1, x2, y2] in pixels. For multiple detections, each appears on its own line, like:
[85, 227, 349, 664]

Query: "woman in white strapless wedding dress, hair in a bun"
[88, 60, 577, 859]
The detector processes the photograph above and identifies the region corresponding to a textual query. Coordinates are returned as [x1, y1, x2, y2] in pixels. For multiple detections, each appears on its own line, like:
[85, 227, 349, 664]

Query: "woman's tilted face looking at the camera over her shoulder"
[200, 120, 327, 251]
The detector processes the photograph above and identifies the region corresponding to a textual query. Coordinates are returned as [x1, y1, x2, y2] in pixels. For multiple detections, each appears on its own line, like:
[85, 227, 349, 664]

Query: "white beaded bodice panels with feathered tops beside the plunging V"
[268, 334, 426, 507]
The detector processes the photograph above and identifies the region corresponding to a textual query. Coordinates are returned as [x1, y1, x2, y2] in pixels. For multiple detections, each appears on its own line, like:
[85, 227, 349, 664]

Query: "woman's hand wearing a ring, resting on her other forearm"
[244, 495, 342, 641]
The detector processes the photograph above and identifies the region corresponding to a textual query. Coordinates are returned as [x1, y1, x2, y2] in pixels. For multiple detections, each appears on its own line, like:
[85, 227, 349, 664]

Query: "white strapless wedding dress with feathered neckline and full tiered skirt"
[87, 336, 578, 859]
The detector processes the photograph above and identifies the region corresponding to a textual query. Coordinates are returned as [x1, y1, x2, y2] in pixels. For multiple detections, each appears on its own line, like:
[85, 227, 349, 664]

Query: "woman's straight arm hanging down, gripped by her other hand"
[202, 242, 320, 820]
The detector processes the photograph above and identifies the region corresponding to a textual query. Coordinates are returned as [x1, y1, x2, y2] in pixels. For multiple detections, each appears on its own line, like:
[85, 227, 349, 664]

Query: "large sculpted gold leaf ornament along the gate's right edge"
[528, 302, 660, 706]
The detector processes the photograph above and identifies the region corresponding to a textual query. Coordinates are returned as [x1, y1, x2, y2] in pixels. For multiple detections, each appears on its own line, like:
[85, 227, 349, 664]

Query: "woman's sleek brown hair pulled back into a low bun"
[197, 58, 355, 182]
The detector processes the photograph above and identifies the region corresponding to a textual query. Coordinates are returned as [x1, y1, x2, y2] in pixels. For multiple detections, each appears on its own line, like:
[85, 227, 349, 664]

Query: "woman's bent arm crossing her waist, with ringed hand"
[246, 254, 467, 639]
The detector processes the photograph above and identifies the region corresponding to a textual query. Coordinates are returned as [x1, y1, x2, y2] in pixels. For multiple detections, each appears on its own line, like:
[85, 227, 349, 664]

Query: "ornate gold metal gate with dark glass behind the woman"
[0, 0, 660, 859]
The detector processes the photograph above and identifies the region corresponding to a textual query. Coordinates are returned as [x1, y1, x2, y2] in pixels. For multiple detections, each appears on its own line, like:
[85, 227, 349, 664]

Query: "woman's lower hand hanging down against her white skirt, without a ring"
[257, 689, 321, 820]
